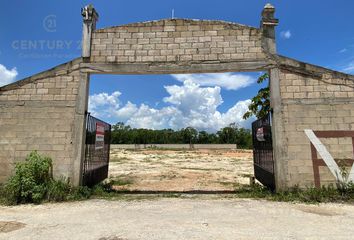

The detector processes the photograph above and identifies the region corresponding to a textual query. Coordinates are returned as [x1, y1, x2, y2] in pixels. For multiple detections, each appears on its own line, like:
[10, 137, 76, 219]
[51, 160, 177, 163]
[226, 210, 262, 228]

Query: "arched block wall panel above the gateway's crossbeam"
[91, 19, 265, 63]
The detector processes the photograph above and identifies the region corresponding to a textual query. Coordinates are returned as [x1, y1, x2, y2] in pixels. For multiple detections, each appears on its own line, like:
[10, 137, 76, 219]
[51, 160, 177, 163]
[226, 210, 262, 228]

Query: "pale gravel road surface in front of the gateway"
[0, 196, 354, 240]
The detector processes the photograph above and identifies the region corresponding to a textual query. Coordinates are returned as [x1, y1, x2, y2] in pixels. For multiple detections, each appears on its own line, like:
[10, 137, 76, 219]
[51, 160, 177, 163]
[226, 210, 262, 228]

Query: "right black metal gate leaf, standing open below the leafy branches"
[252, 114, 275, 190]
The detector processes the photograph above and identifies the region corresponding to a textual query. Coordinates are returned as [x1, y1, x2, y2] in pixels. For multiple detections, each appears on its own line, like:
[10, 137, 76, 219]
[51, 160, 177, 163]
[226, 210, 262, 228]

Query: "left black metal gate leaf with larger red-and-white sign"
[82, 114, 111, 186]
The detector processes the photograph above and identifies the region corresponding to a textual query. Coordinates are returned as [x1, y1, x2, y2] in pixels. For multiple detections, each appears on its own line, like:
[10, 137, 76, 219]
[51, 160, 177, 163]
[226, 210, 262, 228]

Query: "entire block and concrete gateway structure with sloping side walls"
[0, 4, 354, 189]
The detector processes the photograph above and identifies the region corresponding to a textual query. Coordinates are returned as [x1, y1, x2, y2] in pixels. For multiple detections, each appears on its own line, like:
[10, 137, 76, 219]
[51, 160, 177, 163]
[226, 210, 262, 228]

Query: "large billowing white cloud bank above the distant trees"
[90, 80, 252, 131]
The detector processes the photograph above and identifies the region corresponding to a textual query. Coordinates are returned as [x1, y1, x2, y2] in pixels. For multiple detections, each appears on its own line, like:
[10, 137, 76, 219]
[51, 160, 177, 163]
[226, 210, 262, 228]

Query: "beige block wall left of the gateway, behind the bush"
[0, 61, 80, 182]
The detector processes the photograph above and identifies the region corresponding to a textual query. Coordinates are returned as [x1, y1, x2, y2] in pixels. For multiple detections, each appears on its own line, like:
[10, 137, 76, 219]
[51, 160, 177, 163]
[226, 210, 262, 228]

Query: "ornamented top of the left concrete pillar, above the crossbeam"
[81, 4, 98, 58]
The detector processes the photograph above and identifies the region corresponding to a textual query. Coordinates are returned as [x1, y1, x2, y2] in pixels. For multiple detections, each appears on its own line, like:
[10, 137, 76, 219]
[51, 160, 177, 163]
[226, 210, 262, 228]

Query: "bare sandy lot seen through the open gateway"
[109, 149, 253, 191]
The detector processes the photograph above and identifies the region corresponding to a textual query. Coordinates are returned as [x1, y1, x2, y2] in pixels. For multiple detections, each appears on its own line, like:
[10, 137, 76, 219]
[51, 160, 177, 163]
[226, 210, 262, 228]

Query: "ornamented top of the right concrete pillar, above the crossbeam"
[261, 3, 279, 54]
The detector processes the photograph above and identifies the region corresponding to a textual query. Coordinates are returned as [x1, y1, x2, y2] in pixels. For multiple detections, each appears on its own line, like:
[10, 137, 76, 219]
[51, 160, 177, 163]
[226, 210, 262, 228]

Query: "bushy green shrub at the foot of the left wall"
[0, 151, 91, 205]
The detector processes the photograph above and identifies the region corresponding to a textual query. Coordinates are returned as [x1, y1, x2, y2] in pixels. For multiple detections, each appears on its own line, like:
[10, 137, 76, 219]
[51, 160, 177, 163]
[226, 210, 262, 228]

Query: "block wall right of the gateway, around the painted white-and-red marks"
[279, 60, 354, 187]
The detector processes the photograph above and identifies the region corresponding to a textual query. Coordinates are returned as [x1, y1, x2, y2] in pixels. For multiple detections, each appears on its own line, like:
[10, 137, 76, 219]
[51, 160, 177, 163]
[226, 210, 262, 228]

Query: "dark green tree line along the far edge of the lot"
[111, 122, 252, 149]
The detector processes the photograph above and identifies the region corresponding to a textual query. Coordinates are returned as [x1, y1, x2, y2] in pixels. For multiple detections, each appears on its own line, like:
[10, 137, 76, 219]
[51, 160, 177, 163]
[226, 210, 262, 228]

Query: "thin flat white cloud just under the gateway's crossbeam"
[172, 73, 256, 90]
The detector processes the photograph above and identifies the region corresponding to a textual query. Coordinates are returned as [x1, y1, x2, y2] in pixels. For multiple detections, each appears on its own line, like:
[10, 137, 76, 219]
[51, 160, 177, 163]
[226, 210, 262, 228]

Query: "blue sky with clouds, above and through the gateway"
[0, 0, 354, 131]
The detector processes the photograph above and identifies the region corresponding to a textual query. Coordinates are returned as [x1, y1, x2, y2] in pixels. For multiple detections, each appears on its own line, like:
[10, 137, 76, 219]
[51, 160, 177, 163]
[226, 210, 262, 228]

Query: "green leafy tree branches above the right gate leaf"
[243, 73, 271, 119]
